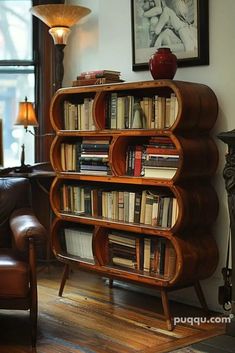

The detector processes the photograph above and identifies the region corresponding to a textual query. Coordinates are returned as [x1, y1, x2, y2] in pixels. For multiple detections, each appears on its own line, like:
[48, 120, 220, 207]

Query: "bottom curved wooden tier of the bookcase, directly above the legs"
[52, 218, 218, 287]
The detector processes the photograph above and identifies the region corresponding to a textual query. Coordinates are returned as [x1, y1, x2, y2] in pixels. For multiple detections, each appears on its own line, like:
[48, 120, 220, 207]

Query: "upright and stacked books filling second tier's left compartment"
[61, 137, 110, 175]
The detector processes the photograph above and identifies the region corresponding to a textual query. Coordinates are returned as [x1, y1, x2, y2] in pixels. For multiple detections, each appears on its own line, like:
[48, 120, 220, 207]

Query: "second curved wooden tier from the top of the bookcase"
[51, 132, 218, 182]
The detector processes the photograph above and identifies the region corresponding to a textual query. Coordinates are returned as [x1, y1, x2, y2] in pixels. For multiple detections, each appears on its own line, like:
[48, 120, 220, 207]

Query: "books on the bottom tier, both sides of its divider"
[61, 227, 176, 279]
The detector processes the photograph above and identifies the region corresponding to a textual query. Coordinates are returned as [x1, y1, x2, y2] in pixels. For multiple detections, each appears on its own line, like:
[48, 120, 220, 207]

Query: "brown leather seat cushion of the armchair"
[0, 249, 29, 299]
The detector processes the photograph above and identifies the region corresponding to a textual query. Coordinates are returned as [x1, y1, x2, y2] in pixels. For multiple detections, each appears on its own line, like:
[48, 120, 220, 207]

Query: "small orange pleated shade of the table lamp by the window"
[15, 97, 38, 129]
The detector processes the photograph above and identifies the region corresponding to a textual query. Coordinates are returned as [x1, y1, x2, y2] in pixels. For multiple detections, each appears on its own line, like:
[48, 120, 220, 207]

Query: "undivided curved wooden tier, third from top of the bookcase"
[50, 177, 218, 233]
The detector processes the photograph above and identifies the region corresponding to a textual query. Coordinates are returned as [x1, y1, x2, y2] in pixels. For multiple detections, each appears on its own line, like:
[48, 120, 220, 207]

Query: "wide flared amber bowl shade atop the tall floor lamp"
[30, 4, 91, 28]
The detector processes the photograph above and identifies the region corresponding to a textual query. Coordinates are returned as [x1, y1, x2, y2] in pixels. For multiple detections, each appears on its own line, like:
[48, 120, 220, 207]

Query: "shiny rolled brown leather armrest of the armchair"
[9, 208, 46, 251]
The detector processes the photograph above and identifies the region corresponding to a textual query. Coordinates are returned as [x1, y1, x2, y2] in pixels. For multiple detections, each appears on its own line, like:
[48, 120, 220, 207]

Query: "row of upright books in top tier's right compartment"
[106, 92, 178, 129]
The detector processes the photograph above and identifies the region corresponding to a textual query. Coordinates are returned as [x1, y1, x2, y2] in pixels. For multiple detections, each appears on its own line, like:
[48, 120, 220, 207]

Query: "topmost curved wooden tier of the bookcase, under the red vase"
[50, 80, 218, 135]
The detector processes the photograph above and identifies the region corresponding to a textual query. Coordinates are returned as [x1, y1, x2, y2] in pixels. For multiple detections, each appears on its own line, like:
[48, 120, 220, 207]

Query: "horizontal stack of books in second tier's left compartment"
[79, 137, 110, 175]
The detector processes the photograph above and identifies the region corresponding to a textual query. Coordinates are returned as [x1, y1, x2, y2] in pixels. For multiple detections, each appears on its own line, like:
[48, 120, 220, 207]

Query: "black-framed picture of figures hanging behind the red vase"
[131, 0, 209, 71]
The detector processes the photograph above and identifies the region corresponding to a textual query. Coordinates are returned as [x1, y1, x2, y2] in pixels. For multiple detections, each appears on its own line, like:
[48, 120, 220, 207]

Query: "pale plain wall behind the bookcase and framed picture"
[63, 0, 235, 310]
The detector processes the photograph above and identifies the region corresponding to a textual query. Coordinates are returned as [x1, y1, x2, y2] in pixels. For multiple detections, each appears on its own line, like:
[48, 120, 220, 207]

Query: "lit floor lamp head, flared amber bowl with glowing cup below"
[30, 4, 91, 45]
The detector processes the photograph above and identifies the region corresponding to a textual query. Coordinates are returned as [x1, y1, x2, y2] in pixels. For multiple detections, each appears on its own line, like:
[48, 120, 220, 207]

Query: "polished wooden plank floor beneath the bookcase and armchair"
[0, 267, 224, 353]
